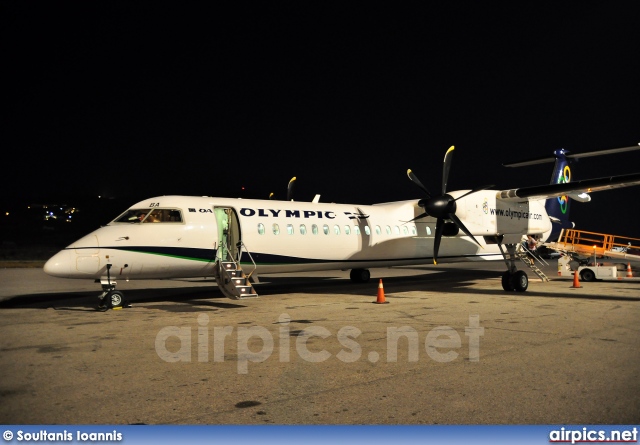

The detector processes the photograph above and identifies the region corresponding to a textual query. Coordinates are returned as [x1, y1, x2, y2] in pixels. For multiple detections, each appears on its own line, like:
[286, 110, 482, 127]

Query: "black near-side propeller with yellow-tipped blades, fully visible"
[407, 145, 493, 264]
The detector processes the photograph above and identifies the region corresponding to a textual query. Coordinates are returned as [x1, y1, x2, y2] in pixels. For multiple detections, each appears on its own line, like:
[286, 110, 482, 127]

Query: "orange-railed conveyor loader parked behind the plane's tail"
[545, 229, 640, 263]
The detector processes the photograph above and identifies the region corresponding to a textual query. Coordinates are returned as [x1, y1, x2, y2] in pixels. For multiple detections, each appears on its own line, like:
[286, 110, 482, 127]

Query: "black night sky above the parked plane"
[5, 2, 640, 238]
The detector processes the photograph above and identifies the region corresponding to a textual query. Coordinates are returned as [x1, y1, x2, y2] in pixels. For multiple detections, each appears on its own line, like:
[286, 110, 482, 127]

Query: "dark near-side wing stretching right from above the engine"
[497, 173, 640, 201]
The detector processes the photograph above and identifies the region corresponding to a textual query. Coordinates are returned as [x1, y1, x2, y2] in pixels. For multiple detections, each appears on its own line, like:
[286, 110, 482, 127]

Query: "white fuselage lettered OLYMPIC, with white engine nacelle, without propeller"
[44, 190, 551, 280]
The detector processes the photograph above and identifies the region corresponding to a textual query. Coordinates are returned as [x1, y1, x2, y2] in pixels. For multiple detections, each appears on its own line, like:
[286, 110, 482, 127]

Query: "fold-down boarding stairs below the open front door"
[214, 243, 258, 300]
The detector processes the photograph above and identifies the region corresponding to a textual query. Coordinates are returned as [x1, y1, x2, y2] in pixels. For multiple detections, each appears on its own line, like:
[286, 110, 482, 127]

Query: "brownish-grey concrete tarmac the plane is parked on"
[0, 261, 640, 425]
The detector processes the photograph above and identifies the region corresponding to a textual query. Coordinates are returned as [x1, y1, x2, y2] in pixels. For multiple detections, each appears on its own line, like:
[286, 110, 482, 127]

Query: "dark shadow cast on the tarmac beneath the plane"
[0, 267, 640, 312]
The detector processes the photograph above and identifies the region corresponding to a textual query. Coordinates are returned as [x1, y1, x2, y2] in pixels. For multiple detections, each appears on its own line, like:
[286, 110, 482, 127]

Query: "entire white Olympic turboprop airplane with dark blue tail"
[44, 146, 640, 308]
